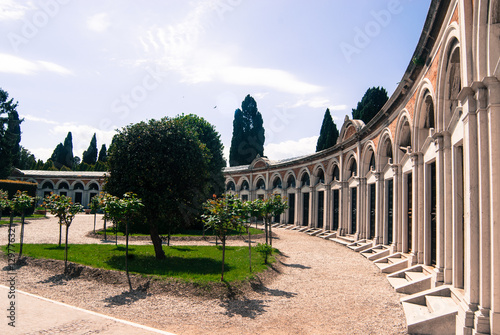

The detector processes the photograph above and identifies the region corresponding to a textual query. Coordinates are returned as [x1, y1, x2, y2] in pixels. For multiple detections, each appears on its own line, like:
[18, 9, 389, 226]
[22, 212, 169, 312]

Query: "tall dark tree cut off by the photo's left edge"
[0, 88, 23, 179]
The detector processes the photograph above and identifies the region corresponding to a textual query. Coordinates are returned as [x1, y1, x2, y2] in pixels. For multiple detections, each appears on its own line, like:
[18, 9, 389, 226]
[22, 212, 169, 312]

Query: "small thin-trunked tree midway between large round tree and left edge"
[47, 194, 83, 273]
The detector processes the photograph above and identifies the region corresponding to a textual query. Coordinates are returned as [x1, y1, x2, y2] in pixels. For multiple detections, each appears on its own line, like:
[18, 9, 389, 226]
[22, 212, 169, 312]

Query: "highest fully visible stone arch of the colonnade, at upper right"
[436, 23, 462, 130]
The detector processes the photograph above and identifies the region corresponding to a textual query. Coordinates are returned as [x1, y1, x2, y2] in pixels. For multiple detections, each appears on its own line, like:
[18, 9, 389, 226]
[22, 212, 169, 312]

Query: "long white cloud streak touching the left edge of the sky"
[0, 53, 73, 75]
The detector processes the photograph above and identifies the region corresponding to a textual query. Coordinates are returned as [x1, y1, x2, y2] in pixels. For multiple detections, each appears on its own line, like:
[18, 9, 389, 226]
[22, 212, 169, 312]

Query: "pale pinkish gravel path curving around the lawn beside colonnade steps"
[0, 215, 406, 334]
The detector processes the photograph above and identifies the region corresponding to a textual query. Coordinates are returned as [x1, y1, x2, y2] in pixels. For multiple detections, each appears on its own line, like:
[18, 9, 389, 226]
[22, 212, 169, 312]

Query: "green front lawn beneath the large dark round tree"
[2, 244, 274, 283]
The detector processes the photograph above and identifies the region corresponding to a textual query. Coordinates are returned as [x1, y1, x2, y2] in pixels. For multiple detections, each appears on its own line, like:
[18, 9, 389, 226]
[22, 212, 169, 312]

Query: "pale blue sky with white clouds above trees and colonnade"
[0, 0, 430, 165]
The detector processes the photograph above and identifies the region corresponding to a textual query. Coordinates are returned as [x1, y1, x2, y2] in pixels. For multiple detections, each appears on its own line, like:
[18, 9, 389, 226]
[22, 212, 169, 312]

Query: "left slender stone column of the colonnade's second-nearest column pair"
[434, 134, 445, 283]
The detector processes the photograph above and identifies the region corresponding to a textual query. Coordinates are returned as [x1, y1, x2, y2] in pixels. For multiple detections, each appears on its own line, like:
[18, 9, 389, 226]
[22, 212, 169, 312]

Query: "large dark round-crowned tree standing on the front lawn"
[106, 118, 210, 259]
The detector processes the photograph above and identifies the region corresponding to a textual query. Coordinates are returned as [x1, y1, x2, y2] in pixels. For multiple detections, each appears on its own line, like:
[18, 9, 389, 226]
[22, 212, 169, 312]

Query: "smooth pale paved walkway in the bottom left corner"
[0, 285, 173, 335]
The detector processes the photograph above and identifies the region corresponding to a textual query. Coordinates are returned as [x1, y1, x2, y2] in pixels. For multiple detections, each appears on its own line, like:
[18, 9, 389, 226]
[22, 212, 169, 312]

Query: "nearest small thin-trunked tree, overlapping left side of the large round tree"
[105, 192, 144, 291]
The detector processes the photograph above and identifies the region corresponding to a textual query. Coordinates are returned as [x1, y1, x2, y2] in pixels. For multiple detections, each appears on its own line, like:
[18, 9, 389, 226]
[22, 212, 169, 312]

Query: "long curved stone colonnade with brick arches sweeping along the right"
[225, 0, 500, 334]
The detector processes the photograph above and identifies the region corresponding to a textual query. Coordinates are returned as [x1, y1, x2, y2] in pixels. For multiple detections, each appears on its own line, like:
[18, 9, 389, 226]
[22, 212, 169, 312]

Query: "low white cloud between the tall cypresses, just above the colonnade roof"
[264, 136, 319, 160]
